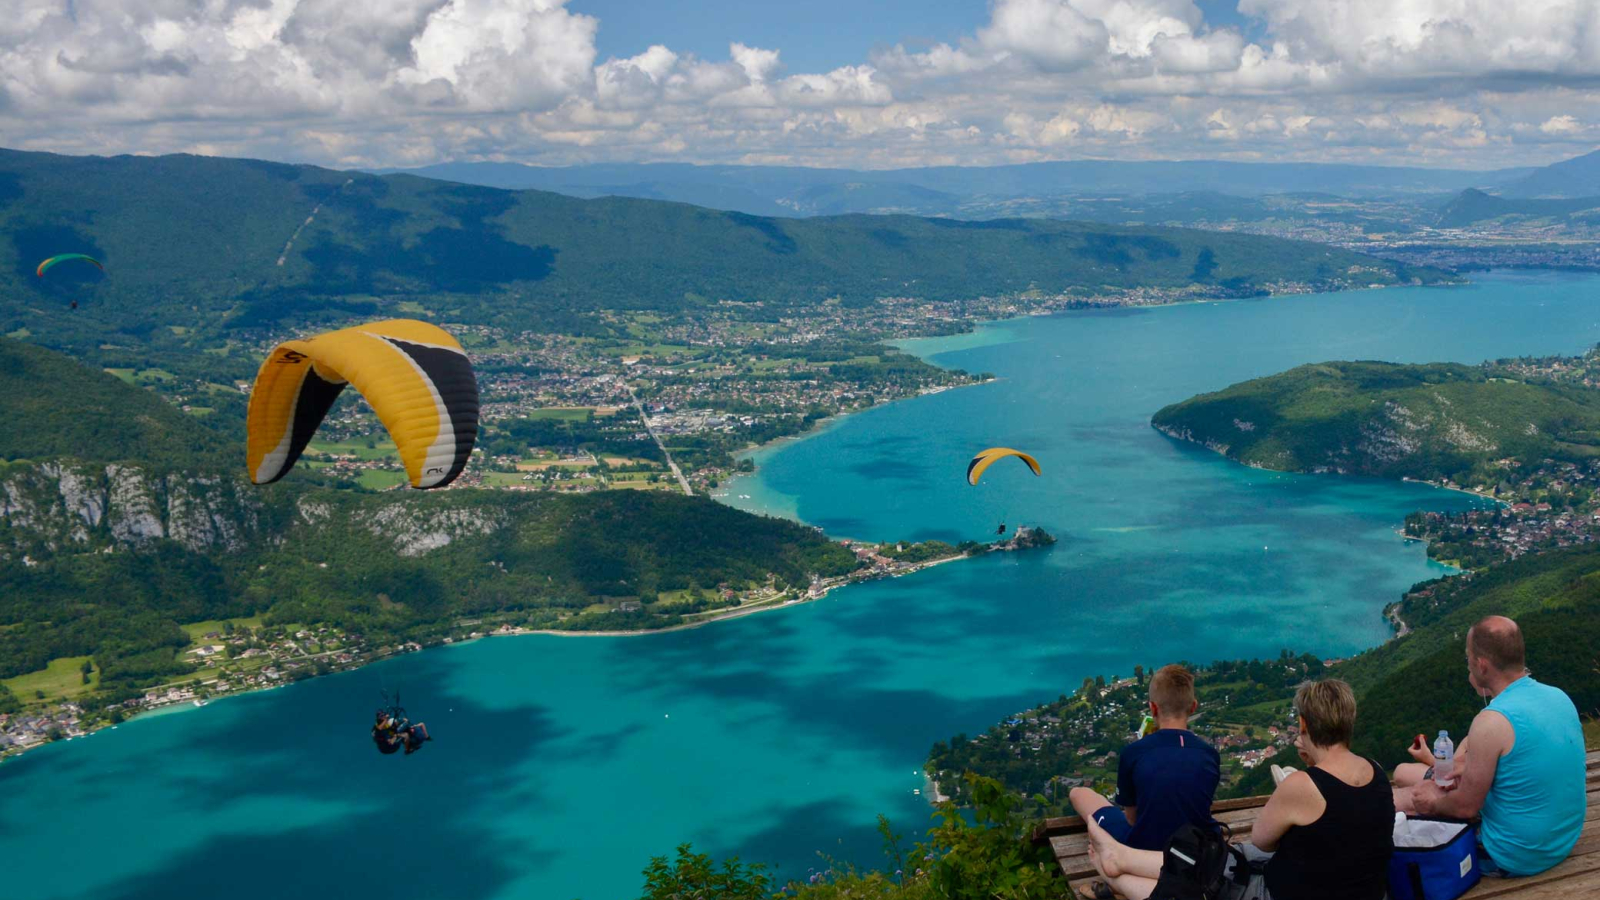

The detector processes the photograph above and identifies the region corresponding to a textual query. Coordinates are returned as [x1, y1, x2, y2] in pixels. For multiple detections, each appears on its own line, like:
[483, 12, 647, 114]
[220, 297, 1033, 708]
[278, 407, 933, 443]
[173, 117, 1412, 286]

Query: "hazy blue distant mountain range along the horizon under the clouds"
[379, 160, 1536, 218]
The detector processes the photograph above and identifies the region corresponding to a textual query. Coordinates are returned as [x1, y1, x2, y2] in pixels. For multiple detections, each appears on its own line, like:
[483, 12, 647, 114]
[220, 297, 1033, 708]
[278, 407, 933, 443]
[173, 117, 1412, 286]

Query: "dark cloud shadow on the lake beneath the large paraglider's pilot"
[31, 643, 588, 900]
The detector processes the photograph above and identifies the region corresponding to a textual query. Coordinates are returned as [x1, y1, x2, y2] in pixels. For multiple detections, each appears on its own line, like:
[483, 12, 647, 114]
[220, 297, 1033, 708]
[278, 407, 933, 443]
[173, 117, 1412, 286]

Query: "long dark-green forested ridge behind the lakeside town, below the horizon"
[0, 151, 1445, 355]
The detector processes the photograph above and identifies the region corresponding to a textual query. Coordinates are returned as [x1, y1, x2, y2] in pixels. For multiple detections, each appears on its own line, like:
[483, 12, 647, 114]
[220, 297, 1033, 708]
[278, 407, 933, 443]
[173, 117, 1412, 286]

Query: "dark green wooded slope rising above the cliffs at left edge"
[0, 338, 228, 469]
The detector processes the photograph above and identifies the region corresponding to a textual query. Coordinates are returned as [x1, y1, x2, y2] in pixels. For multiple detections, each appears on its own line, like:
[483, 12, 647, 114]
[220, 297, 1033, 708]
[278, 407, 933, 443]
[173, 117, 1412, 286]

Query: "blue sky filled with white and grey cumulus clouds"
[0, 0, 1600, 168]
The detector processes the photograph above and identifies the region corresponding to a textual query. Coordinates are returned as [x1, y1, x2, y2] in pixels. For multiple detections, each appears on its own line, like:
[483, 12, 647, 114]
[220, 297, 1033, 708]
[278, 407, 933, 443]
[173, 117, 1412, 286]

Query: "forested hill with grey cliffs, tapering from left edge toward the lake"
[0, 338, 856, 690]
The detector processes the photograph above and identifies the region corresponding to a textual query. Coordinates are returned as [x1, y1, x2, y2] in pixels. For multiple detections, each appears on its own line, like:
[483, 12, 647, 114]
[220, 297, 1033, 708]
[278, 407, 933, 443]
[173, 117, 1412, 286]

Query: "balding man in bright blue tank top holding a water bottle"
[1394, 615, 1584, 876]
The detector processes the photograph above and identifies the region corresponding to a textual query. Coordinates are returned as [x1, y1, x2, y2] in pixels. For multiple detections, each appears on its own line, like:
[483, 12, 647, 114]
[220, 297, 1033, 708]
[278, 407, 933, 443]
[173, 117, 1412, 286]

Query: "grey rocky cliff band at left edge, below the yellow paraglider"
[0, 463, 261, 559]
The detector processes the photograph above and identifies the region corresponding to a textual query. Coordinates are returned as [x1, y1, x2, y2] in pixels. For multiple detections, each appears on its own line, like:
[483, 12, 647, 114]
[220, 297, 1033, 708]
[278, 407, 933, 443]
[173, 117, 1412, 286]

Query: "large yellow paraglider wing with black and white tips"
[246, 319, 478, 488]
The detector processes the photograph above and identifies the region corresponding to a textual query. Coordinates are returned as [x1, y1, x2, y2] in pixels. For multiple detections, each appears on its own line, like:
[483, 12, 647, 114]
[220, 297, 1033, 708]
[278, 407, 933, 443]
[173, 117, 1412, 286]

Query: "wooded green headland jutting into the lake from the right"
[1150, 362, 1600, 485]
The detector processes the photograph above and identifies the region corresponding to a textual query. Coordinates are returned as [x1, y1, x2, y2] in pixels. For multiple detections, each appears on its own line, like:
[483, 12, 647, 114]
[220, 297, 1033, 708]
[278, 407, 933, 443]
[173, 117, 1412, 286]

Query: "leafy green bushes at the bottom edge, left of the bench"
[642, 777, 1066, 900]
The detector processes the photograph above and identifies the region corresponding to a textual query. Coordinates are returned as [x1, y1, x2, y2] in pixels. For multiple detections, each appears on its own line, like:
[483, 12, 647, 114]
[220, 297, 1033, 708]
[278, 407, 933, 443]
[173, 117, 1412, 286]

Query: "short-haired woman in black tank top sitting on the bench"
[1085, 679, 1395, 900]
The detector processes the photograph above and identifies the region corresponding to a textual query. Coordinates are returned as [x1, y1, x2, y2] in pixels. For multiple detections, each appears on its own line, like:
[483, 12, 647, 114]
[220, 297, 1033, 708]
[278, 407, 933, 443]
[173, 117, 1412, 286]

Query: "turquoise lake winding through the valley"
[0, 274, 1600, 900]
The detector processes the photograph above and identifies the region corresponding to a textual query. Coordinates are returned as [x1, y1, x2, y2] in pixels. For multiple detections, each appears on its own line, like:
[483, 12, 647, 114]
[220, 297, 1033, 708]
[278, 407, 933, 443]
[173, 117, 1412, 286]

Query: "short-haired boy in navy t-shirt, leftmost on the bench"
[1072, 666, 1222, 850]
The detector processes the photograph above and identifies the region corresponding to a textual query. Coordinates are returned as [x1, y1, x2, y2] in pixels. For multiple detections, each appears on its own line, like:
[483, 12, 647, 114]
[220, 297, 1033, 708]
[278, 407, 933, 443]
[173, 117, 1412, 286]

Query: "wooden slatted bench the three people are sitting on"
[1034, 751, 1600, 900]
